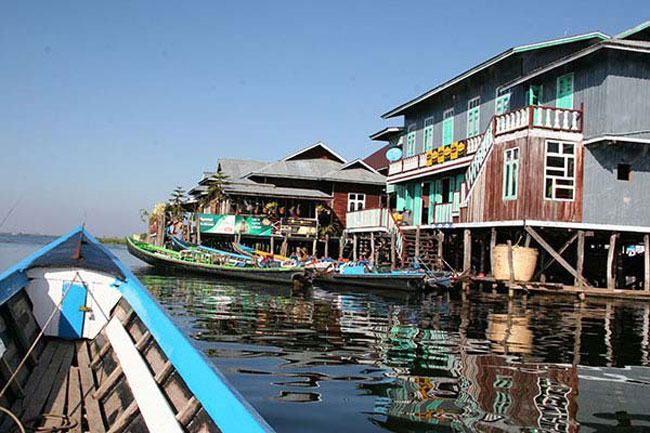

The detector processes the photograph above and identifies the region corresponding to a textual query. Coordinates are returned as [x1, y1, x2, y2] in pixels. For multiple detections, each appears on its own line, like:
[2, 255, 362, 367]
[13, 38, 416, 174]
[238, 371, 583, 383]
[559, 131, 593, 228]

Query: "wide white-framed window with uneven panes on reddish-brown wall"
[544, 141, 576, 201]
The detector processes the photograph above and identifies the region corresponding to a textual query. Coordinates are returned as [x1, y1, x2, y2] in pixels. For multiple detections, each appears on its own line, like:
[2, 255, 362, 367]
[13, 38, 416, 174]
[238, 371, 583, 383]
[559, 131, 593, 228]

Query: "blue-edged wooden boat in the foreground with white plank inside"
[0, 227, 273, 433]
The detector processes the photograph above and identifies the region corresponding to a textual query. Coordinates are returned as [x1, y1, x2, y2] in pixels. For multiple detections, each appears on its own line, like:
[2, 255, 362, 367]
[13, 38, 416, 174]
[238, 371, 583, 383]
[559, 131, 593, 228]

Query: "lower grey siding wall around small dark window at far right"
[583, 142, 650, 226]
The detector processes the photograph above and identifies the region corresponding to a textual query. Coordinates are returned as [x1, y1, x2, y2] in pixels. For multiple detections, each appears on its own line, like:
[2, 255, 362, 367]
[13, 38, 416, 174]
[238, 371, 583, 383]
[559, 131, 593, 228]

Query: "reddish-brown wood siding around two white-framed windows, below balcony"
[462, 134, 583, 222]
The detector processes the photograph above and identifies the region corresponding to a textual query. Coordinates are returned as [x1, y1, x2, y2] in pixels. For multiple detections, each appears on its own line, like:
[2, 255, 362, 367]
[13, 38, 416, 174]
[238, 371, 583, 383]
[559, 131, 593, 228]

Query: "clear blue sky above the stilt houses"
[0, 0, 650, 236]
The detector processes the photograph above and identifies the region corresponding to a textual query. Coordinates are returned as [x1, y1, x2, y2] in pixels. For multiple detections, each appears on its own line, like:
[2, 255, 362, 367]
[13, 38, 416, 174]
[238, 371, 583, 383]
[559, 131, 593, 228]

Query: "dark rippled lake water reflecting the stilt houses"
[0, 235, 650, 433]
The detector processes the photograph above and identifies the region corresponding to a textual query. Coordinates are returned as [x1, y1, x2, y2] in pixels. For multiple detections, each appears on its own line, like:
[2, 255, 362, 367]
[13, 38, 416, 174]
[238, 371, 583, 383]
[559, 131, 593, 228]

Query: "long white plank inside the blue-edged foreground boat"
[106, 319, 182, 433]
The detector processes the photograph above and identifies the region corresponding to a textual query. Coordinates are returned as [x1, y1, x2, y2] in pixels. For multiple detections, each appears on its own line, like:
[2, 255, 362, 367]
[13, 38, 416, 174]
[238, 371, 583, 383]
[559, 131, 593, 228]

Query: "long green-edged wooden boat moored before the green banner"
[126, 238, 310, 285]
